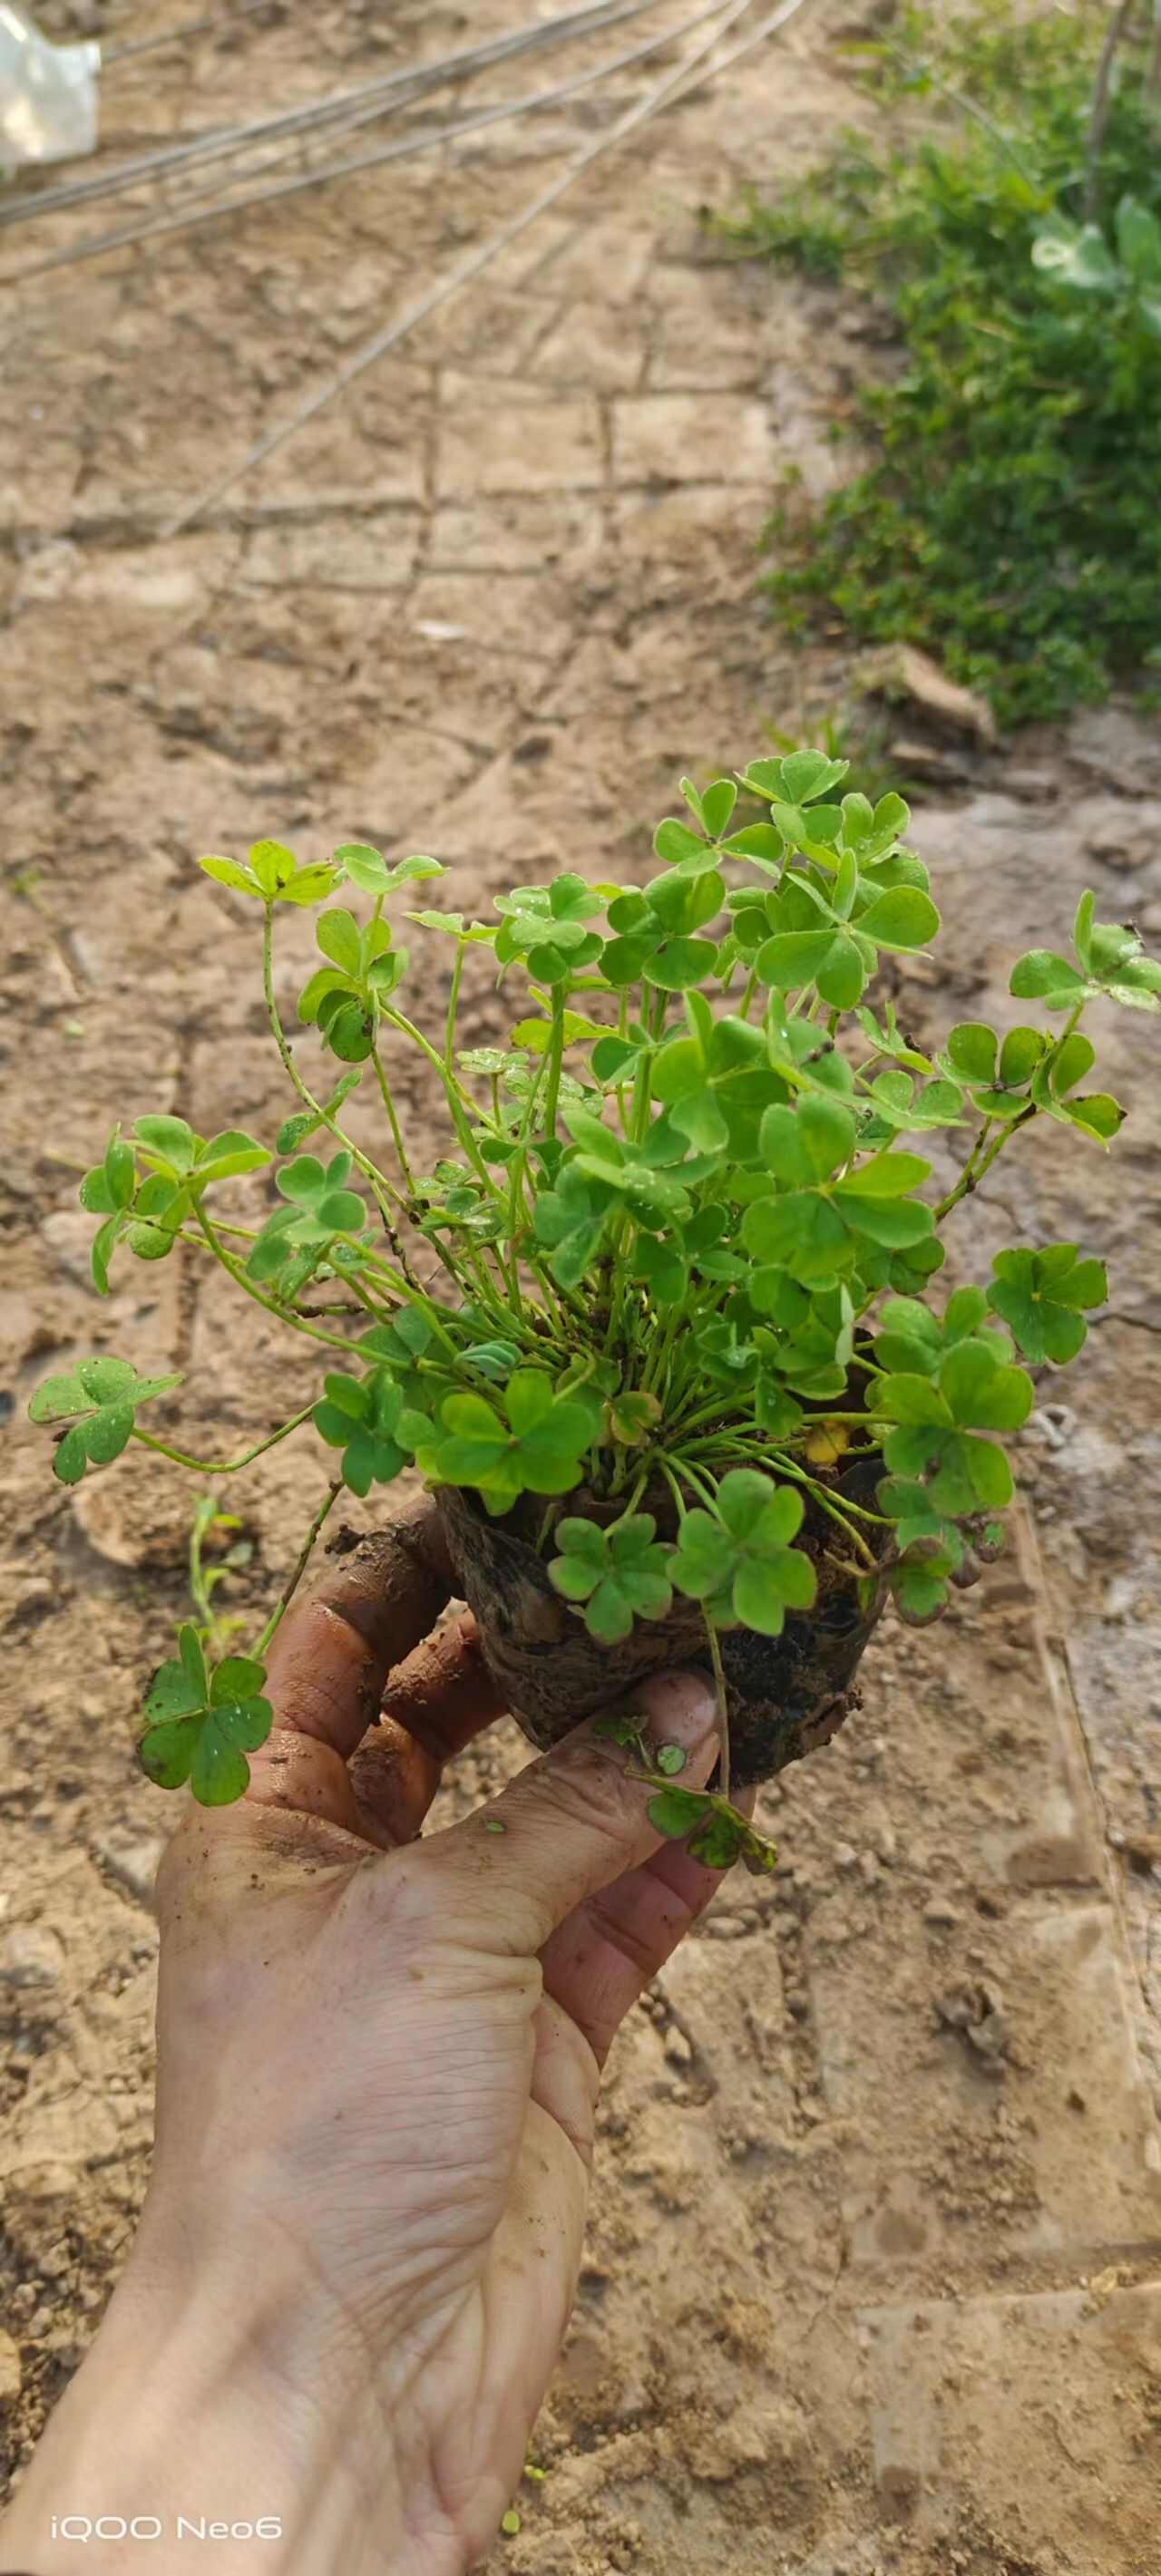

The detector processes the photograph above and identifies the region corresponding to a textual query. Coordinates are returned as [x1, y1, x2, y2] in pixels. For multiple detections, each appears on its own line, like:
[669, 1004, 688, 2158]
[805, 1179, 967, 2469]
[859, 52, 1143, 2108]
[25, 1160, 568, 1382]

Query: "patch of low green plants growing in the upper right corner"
[718, 5, 1161, 724]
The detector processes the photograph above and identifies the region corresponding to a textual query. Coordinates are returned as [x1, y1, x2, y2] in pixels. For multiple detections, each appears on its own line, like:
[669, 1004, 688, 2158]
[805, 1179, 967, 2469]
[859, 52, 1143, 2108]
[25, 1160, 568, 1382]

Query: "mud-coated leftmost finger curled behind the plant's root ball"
[265, 1494, 454, 1762]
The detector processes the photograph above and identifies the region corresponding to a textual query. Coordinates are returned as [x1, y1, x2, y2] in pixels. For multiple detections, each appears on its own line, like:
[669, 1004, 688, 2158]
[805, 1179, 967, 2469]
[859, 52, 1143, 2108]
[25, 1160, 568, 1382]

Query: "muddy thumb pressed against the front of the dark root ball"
[420, 1672, 718, 1955]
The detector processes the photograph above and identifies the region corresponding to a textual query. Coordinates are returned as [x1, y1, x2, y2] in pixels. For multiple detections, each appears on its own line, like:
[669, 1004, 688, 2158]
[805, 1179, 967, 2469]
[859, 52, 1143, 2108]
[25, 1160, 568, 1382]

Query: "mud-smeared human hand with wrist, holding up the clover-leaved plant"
[5, 1504, 718, 2576]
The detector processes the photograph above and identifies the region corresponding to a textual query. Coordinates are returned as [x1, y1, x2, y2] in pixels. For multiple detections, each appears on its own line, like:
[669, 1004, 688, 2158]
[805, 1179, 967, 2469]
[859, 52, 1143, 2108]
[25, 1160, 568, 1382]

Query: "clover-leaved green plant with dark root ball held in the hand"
[31, 750, 1161, 1868]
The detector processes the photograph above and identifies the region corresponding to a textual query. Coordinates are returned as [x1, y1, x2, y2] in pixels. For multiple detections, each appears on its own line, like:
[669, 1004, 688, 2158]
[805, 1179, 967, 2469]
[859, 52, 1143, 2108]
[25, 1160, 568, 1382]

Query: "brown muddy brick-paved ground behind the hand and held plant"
[0, 0, 1161, 2576]
